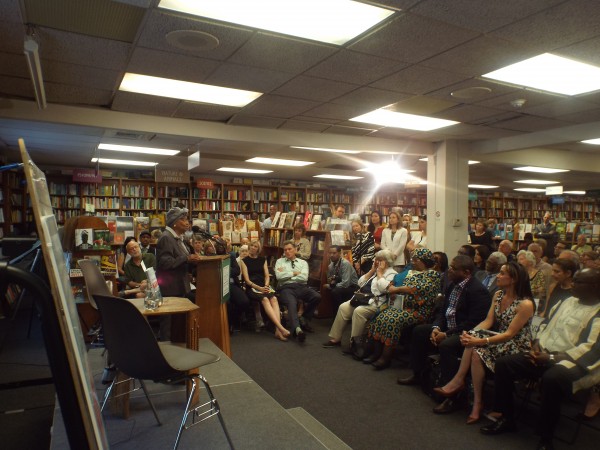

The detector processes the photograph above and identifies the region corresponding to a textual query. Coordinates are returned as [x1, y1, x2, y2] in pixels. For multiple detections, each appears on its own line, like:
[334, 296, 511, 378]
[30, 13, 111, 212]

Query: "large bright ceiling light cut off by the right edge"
[483, 53, 600, 95]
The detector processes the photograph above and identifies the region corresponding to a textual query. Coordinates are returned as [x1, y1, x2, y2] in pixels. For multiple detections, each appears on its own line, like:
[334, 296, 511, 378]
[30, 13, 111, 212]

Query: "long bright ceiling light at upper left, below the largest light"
[119, 72, 262, 108]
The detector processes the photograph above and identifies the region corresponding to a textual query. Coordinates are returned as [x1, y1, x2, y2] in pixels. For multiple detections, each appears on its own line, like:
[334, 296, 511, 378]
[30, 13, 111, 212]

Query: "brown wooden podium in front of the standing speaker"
[196, 255, 231, 358]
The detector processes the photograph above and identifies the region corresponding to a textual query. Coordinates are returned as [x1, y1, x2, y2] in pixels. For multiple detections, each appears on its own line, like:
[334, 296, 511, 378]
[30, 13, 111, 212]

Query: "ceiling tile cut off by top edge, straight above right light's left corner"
[410, 0, 563, 33]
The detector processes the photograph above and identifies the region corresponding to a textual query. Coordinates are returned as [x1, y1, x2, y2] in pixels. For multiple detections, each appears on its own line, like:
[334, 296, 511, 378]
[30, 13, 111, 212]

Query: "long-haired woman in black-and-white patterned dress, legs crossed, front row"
[434, 262, 535, 425]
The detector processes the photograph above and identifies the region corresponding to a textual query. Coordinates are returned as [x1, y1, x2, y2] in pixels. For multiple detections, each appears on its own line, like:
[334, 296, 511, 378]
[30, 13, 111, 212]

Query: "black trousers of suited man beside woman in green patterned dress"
[410, 323, 464, 386]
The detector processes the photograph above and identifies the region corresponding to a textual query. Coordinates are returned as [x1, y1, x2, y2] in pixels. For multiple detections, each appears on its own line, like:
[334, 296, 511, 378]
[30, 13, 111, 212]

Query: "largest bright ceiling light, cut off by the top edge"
[158, 0, 394, 45]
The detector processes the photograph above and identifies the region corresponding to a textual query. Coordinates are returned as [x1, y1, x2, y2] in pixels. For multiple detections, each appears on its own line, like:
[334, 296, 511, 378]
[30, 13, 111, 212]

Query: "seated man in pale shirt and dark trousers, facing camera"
[275, 241, 321, 343]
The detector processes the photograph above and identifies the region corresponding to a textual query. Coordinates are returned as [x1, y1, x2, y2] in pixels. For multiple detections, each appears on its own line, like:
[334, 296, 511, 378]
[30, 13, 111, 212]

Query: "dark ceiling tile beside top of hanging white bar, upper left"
[37, 28, 131, 70]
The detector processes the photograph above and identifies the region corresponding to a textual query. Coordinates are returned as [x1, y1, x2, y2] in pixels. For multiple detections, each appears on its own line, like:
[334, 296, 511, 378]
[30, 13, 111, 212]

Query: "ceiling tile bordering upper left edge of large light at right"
[423, 36, 537, 76]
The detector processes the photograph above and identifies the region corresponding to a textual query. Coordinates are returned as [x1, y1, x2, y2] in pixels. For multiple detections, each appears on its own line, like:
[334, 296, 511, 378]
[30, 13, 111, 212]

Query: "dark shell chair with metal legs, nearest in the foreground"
[94, 295, 233, 449]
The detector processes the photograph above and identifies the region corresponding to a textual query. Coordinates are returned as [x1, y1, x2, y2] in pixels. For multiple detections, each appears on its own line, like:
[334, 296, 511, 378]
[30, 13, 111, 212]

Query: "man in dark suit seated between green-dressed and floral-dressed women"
[398, 255, 492, 414]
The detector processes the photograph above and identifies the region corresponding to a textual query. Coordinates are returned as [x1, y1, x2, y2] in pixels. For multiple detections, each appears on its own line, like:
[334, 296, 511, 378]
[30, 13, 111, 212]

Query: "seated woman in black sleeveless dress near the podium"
[240, 241, 290, 341]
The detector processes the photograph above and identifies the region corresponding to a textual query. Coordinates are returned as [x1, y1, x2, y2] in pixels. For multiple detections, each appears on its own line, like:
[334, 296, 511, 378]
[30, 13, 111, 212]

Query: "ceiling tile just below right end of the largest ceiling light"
[306, 50, 407, 84]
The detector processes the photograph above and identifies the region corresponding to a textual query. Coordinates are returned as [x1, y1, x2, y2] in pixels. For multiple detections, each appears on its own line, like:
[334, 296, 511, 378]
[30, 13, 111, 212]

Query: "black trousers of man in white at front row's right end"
[494, 354, 585, 439]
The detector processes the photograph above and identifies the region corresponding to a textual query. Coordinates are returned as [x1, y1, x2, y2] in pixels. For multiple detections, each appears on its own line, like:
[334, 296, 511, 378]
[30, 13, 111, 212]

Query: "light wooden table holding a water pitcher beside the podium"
[115, 297, 200, 418]
